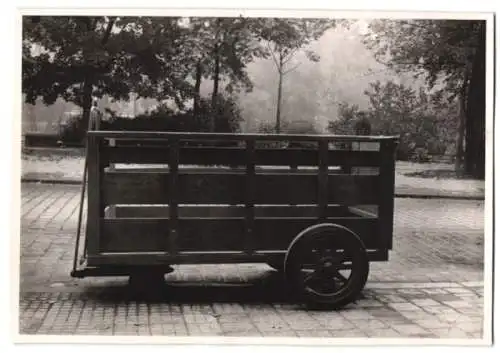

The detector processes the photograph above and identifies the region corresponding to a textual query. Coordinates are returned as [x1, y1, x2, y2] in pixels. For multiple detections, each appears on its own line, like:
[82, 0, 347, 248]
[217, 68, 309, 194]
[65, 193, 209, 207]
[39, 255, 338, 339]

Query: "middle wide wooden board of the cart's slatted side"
[103, 171, 380, 206]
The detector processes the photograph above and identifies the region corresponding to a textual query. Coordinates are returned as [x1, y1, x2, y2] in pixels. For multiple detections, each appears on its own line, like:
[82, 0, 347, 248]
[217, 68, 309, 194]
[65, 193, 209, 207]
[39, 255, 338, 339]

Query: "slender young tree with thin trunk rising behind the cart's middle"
[259, 18, 335, 133]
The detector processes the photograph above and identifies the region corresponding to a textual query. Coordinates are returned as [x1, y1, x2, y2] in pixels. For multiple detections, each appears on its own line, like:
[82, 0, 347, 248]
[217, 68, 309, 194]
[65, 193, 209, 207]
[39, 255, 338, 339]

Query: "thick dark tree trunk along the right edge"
[465, 21, 486, 179]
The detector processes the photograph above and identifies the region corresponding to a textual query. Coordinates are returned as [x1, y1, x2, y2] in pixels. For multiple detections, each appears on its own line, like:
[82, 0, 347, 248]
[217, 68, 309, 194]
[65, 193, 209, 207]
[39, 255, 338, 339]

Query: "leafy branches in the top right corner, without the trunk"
[364, 20, 481, 100]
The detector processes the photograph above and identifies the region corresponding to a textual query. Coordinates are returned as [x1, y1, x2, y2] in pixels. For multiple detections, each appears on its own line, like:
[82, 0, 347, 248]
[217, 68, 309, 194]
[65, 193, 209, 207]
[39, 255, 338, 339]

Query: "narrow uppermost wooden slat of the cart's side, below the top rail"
[103, 146, 380, 167]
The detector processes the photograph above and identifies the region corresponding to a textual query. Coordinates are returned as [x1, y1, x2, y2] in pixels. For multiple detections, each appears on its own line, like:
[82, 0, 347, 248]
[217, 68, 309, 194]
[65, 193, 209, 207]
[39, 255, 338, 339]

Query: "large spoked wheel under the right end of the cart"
[285, 224, 369, 308]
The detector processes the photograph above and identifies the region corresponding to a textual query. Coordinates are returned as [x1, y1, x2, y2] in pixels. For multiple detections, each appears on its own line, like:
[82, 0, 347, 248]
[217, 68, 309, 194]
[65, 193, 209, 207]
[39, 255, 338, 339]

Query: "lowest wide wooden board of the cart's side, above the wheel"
[99, 217, 378, 255]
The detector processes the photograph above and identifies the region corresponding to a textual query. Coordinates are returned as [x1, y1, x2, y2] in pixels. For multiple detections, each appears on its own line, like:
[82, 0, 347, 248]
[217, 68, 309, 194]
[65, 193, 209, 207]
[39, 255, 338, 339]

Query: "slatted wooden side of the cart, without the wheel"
[86, 131, 395, 266]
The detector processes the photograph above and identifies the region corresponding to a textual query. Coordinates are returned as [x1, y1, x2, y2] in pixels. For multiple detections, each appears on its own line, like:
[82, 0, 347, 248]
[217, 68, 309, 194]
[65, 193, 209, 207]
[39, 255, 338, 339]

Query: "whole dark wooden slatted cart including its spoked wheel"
[72, 131, 397, 305]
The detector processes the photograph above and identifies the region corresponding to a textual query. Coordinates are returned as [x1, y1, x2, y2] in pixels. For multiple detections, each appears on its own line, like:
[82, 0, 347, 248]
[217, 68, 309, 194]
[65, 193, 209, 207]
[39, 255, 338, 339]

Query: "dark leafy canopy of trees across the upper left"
[23, 16, 328, 135]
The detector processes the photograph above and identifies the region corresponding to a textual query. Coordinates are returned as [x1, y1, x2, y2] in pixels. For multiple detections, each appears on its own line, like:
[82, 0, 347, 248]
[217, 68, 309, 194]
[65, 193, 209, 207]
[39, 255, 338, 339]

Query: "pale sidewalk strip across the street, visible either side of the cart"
[21, 153, 485, 200]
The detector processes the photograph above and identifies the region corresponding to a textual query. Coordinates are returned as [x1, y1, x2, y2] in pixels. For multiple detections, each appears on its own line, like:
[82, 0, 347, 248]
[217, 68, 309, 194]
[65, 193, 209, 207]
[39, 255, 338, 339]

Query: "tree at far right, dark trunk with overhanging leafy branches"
[365, 20, 486, 178]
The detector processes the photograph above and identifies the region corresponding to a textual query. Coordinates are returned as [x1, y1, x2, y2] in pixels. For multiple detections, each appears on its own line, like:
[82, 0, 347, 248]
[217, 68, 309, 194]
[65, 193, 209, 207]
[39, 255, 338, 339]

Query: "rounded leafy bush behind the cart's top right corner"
[329, 81, 456, 160]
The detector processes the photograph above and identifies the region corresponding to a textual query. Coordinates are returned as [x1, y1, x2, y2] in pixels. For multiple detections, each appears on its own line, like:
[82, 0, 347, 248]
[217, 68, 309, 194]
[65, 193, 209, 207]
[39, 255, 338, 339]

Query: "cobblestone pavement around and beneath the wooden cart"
[19, 184, 484, 338]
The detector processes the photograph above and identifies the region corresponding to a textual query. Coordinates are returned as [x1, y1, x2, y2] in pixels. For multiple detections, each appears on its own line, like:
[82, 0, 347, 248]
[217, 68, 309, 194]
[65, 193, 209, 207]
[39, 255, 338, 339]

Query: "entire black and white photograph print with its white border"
[15, 6, 494, 345]
